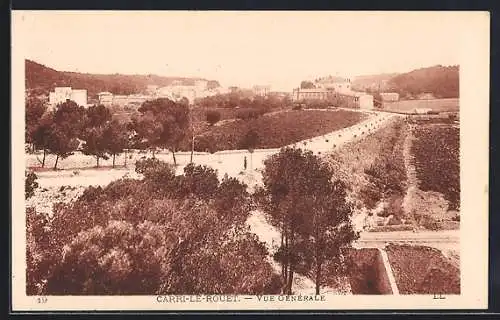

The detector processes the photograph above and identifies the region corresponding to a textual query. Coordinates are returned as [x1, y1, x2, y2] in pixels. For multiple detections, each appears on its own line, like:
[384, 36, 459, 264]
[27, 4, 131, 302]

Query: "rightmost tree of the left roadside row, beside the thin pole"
[136, 98, 190, 165]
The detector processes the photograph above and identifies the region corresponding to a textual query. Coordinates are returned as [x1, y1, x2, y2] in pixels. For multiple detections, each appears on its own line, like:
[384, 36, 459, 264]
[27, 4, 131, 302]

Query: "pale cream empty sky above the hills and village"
[12, 11, 470, 91]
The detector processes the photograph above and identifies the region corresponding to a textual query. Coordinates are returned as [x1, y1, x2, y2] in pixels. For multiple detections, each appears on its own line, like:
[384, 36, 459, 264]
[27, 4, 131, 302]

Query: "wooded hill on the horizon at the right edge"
[352, 65, 459, 99]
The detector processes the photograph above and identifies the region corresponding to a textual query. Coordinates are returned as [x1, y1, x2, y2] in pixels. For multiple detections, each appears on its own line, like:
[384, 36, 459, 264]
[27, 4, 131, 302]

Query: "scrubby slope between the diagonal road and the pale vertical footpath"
[329, 120, 407, 228]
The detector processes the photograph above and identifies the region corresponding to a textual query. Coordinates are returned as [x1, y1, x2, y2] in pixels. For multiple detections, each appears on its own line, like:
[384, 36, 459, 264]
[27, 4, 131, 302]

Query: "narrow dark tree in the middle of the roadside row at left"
[82, 105, 114, 167]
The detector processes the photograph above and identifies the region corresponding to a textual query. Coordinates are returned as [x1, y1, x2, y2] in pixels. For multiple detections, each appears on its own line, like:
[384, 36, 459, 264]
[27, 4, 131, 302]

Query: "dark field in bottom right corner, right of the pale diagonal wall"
[386, 244, 460, 294]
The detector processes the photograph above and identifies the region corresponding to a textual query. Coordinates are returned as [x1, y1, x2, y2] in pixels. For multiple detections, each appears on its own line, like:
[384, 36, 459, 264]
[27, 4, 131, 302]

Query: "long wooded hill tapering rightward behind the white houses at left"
[25, 60, 220, 98]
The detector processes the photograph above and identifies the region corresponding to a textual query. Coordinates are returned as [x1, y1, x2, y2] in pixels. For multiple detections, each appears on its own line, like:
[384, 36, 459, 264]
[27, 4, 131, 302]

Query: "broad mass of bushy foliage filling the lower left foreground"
[27, 159, 281, 295]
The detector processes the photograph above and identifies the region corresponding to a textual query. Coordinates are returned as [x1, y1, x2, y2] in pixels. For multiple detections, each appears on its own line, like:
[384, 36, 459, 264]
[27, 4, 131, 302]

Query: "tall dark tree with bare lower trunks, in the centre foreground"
[263, 148, 356, 294]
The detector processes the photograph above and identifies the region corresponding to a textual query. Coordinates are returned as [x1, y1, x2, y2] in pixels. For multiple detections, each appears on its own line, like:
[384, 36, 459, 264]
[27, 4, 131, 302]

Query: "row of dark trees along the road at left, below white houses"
[25, 99, 195, 169]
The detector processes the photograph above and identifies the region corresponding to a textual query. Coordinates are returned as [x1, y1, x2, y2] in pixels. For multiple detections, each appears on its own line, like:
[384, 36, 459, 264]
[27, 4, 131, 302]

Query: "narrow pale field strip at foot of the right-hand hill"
[383, 98, 459, 113]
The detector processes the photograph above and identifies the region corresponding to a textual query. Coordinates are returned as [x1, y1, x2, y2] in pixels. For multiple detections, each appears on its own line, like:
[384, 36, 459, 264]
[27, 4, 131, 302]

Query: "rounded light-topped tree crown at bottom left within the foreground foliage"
[47, 221, 178, 295]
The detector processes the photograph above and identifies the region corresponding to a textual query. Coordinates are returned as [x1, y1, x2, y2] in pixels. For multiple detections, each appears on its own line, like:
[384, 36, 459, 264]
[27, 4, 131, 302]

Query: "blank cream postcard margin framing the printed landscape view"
[11, 11, 490, 311]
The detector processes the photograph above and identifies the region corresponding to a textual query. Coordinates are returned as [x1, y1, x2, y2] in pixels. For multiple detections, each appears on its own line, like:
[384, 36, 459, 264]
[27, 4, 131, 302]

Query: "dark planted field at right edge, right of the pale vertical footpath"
[412, 125, 460, 210]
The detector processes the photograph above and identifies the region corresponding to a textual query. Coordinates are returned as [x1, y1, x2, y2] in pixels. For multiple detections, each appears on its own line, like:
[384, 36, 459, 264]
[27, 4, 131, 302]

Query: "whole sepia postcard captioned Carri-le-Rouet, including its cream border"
[11, 11, 490, 312]
